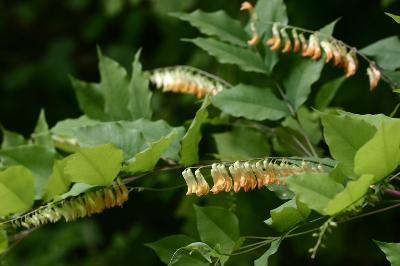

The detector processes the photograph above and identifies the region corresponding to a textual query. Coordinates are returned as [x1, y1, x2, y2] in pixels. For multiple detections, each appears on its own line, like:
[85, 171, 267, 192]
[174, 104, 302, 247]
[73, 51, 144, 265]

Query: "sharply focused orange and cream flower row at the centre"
[182, 159, 323, 196]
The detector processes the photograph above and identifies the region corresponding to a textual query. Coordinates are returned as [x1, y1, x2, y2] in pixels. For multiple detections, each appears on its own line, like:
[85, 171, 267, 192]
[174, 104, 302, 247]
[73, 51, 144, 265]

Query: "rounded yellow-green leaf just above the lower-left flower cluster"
[65, 144, 123, 186]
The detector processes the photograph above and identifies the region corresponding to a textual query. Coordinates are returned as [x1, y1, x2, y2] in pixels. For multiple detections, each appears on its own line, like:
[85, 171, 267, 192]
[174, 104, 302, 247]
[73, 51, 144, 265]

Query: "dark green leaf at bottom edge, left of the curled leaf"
[146, 235, 208, 266]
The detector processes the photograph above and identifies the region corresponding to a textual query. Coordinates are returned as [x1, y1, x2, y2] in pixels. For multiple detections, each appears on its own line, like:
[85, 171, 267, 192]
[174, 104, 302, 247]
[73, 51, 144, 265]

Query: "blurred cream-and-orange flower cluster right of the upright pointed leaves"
[150, 66, 228, 98]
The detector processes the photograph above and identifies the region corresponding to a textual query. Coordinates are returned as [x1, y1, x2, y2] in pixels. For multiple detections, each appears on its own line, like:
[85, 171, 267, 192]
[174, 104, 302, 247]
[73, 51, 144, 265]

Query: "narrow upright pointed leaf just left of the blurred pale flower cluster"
[127, 50, 152, 120]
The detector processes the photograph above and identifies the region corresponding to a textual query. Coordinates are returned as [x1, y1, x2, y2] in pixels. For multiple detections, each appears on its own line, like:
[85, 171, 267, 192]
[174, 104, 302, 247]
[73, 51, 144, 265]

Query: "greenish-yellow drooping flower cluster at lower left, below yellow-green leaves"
[7, 179, 129, 229]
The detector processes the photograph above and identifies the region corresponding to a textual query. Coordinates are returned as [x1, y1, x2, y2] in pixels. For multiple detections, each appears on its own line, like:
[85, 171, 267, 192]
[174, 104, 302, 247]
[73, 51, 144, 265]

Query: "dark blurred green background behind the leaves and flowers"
[0, 0, 400, 266]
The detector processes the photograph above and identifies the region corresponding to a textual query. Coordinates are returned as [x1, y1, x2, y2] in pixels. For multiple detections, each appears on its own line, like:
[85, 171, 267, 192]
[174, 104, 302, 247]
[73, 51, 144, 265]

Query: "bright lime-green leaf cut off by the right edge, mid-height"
[354, 121, 400, 181]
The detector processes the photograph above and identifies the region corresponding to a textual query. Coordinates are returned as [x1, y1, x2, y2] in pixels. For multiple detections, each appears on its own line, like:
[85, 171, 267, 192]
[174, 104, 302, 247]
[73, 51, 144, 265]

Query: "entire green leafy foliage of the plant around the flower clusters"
[0, 0, 400, 265]
